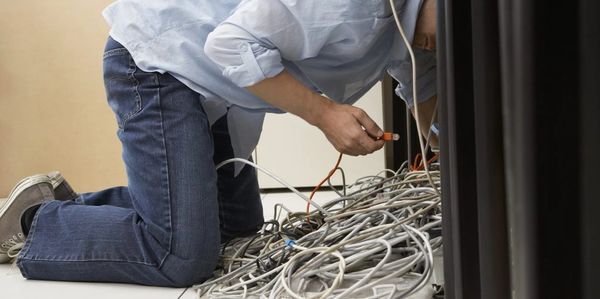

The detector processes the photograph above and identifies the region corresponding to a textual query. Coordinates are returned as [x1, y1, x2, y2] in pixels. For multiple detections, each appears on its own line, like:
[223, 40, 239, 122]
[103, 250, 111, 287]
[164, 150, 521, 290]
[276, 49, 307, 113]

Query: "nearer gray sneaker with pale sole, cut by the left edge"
[0, 174, 54, 263]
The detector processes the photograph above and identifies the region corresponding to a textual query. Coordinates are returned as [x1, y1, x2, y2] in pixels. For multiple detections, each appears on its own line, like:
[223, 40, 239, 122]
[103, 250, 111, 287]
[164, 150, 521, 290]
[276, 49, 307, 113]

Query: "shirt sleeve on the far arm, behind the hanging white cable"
[388, 49, 437, 107]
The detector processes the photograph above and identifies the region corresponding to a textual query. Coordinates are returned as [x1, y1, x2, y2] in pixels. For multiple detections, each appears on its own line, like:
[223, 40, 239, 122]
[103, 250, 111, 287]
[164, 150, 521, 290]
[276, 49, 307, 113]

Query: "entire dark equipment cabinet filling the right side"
[438, 0, 600, 299]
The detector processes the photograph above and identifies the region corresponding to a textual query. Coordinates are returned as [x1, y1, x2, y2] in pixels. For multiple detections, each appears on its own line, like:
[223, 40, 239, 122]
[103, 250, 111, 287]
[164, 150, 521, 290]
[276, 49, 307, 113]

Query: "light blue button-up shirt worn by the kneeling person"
[103, 0, 436, 175]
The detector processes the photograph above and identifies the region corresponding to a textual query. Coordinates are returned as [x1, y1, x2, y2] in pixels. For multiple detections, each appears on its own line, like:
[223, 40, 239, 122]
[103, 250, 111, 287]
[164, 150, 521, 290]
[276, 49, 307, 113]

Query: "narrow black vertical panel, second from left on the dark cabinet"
[472, 0, 510, 299]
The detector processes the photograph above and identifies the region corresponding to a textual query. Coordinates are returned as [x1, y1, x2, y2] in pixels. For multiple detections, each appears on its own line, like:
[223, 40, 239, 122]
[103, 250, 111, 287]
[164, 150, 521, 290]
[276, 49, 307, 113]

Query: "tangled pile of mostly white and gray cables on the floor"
[194, 165, 442, 298]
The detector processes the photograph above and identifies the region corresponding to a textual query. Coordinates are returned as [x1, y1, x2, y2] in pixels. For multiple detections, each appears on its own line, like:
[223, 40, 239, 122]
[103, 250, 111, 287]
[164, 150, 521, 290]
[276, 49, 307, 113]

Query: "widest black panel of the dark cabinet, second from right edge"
[504, 1, 581, 298]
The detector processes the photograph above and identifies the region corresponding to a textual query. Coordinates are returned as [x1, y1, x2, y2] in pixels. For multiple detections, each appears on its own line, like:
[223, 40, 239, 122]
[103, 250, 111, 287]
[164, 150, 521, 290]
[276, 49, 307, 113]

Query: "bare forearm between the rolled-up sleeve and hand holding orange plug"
[247, 71, 332, 126]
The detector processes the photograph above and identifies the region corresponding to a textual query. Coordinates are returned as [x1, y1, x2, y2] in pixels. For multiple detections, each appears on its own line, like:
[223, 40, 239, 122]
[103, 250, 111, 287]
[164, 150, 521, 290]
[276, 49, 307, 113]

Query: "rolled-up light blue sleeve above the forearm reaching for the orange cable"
[204, 0, 306, 87]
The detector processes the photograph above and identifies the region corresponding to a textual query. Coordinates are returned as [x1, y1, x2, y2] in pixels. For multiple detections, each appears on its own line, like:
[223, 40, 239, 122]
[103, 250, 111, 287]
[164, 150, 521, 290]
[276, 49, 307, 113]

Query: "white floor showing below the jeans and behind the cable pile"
[0, 192, 336, 299]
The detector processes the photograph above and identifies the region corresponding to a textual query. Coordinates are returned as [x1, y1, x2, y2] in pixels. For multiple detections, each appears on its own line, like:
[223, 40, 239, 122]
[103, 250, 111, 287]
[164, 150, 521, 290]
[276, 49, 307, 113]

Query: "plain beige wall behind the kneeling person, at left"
[0, 0, 126, 197]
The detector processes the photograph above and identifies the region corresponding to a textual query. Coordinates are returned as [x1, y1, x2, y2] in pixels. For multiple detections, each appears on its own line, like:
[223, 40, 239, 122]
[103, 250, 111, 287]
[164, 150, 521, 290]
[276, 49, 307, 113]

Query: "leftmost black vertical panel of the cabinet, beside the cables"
[438, 0, 480, 299]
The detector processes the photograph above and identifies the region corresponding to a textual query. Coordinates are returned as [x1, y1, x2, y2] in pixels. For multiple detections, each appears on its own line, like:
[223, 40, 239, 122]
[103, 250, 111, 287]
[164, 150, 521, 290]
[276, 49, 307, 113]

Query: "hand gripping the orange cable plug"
[315, 102, 384, 156]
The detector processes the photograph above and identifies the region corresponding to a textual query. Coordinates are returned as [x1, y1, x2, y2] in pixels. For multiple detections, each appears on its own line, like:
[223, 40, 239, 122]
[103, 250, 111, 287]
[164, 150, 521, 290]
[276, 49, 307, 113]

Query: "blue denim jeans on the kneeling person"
[17, 39, 263, 287]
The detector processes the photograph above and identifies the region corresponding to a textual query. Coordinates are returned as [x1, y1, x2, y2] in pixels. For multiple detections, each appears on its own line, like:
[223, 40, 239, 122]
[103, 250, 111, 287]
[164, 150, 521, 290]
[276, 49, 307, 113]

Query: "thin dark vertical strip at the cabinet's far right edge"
[579, 0, 600, 299]
